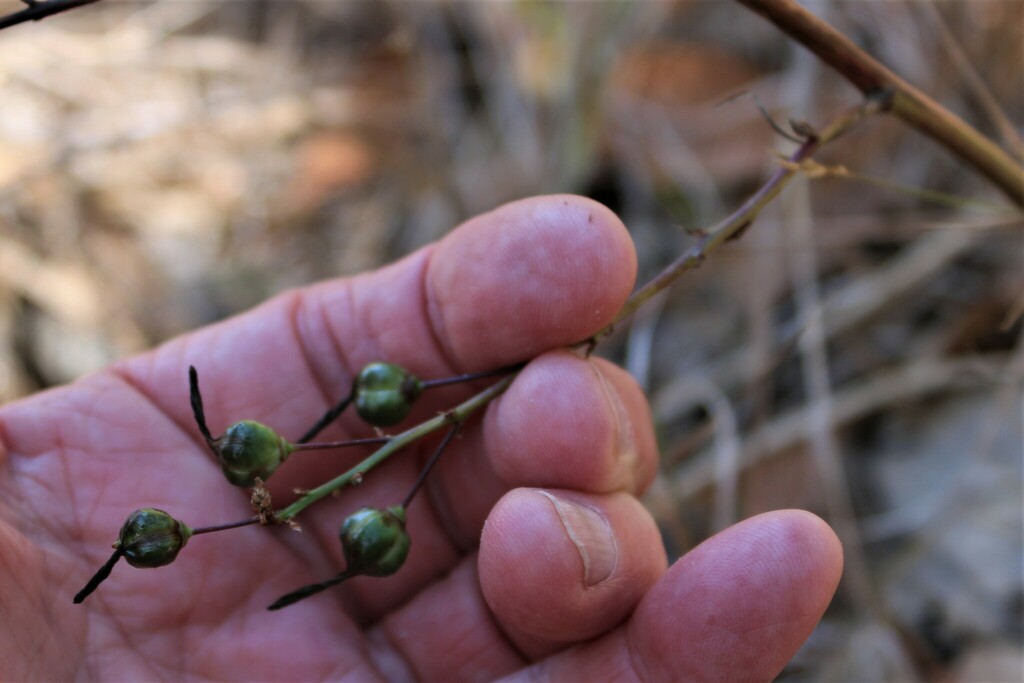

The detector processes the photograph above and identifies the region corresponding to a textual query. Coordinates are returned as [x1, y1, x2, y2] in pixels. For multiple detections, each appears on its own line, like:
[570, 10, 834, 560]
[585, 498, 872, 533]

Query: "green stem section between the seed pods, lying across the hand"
[274, 371, 518, 522]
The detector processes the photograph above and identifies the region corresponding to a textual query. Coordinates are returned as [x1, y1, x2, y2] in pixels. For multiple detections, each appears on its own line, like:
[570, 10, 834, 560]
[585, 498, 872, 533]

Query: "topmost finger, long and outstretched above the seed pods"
[114, 197, 636, 448]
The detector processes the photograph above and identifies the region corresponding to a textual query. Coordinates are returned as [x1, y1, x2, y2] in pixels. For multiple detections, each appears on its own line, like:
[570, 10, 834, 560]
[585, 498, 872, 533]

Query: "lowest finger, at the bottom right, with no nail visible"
[493, 510, 843, 681]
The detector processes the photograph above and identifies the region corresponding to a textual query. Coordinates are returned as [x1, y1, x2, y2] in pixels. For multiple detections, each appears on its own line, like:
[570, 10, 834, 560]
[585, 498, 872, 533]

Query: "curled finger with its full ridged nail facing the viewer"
[479, 488, 666, 658]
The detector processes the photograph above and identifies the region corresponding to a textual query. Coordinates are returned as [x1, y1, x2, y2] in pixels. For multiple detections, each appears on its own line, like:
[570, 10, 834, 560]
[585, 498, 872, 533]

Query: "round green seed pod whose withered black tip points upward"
[213, 420, 295, 486]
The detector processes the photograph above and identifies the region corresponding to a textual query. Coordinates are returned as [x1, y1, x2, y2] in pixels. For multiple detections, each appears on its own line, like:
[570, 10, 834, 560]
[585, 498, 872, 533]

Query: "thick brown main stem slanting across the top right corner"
[737, 0, 1024, 206]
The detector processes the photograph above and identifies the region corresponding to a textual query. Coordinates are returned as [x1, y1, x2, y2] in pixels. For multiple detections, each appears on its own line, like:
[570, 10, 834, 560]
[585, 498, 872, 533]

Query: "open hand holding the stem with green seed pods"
[0, 197, 842, 681]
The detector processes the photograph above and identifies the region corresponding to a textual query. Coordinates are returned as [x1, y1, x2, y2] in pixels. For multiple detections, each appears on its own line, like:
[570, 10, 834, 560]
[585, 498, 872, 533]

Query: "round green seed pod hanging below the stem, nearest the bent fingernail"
[338, 505, 410, 577]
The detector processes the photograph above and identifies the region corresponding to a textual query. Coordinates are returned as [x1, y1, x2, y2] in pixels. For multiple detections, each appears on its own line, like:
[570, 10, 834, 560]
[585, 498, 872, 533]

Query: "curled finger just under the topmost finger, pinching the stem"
[276, 351, 656, 622]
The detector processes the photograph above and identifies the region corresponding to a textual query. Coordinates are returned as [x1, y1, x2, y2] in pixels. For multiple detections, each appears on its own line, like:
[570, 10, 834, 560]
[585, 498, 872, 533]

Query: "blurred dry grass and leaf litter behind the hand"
[0, 0, 1024, 681]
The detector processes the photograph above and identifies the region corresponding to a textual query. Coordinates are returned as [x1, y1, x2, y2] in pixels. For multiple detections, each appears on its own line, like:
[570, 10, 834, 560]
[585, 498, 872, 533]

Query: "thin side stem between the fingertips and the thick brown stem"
[581, 91, 892, 348]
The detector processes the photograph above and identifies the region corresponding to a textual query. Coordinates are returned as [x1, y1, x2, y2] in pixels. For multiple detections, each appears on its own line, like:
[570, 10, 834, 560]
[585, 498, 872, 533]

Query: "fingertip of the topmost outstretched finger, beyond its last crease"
[426, 195, 637, 370]
